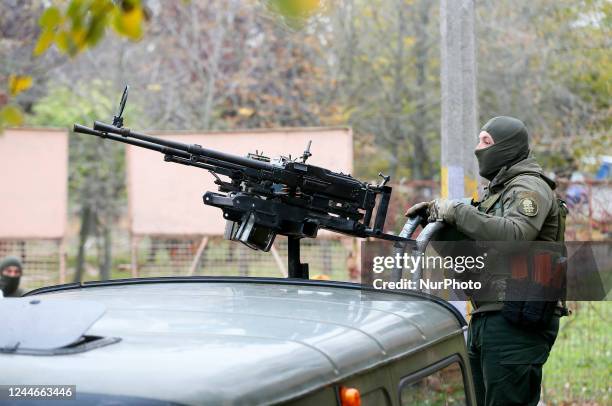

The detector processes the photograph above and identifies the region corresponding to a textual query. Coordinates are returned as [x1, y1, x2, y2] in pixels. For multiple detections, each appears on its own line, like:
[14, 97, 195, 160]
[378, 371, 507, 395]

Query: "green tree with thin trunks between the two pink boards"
[30, 82, 130, 282]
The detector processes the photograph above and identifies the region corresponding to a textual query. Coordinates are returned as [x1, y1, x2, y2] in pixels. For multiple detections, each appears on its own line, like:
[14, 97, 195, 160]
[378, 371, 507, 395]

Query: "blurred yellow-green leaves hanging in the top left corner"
[0, 0, 149, 132]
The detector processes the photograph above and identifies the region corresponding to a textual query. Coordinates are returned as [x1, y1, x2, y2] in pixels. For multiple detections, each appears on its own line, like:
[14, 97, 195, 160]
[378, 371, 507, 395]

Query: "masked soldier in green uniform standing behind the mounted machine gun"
[406, 117, 565, 406]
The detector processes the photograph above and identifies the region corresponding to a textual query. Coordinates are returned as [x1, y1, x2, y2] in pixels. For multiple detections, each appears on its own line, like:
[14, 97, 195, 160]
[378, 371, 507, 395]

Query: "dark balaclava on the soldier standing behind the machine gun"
[474, 116, 529, 181]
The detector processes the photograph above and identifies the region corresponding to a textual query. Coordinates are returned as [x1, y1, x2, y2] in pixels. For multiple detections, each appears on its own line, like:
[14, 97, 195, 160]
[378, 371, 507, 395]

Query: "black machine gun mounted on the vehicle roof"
[74, 86, 407, 278]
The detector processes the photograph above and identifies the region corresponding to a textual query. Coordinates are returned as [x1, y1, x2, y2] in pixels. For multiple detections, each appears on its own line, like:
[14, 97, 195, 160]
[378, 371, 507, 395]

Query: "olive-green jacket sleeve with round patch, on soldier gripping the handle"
[453, 176, 553, 241]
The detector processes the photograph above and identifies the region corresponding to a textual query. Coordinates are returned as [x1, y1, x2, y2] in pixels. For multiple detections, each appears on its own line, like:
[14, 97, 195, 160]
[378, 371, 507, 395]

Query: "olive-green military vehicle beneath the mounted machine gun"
[0, 277, 475, 406]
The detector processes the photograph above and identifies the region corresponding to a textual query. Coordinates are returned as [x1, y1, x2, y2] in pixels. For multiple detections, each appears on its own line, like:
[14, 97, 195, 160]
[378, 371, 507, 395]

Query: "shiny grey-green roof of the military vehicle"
[0, 282, 461, 404]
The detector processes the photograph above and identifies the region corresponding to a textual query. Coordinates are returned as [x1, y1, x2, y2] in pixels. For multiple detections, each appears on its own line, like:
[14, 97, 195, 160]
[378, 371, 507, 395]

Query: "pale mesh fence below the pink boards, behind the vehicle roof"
[0, 230, 360, 290]
